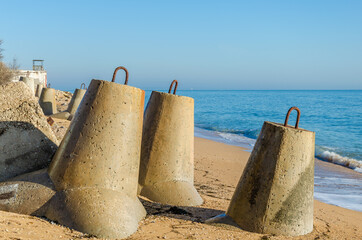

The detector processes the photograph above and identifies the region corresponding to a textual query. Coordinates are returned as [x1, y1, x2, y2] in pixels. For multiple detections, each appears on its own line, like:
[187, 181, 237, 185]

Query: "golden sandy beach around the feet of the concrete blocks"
[0, 126, 362, 240]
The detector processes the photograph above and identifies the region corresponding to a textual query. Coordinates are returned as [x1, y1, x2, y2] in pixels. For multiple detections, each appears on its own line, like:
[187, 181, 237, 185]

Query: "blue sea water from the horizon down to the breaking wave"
[170, 91, 362, 172]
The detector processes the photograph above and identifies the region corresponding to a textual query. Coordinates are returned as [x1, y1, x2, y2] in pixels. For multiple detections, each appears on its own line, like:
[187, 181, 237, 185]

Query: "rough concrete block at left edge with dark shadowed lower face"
[0, 82, 58, 181]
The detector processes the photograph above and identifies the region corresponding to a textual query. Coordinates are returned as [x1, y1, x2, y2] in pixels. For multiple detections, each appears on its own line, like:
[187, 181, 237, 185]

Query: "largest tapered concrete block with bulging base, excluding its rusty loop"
[46, 80, 146, 238]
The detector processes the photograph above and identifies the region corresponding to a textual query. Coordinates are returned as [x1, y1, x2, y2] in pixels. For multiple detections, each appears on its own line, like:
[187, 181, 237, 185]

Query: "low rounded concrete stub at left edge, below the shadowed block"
[0, 169, 55, 216]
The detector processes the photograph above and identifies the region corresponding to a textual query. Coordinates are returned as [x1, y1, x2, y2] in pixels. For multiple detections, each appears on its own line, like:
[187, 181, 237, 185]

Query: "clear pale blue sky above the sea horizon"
[0, 0, 362, 90]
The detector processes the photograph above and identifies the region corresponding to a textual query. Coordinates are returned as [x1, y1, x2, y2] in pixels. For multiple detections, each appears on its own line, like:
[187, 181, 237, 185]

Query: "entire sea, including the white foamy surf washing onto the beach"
[146, 90, 362, 211]
